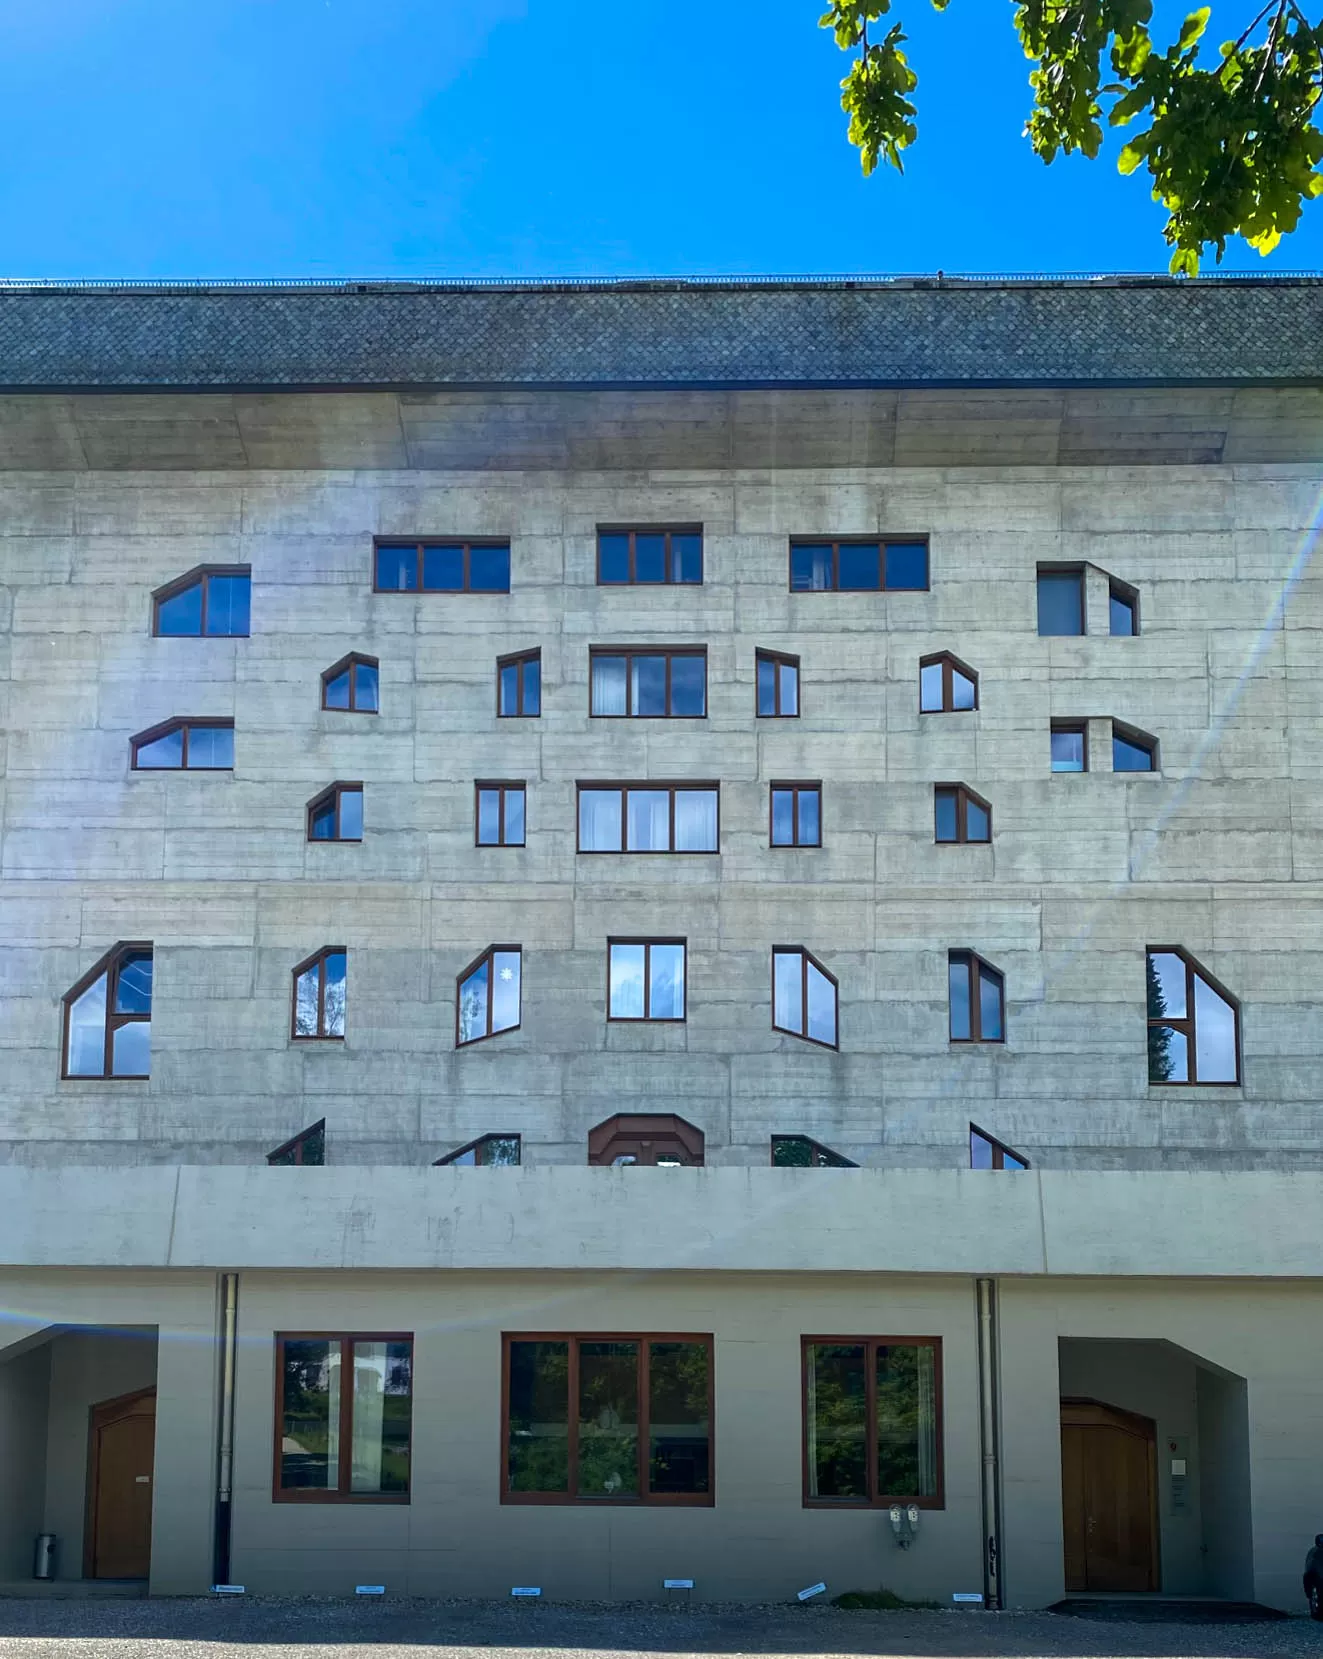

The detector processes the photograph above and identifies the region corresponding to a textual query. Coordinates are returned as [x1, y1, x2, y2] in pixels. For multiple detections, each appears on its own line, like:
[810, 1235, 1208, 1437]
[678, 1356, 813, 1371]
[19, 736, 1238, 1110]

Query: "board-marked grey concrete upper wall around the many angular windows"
[0, 441, 1323, 1168]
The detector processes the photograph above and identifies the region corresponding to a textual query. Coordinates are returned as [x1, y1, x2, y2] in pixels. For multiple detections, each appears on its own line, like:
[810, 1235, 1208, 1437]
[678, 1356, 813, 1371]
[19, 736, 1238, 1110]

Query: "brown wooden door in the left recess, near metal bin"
[83, 1389, 156, 1578]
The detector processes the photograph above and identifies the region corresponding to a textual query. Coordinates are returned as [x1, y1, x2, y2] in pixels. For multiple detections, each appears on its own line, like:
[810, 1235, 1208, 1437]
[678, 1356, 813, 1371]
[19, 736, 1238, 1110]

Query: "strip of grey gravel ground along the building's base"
[0, 1598, 1323, 1659]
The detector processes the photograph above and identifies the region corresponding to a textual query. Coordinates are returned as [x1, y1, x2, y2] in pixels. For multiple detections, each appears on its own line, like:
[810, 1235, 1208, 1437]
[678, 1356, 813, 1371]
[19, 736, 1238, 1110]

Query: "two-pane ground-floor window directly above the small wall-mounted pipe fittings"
[803, 1337, 945, 1510]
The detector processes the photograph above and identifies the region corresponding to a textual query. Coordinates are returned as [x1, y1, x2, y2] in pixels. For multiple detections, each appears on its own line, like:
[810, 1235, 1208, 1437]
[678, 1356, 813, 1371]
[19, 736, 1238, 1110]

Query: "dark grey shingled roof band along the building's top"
[0, 279, 1323, 390]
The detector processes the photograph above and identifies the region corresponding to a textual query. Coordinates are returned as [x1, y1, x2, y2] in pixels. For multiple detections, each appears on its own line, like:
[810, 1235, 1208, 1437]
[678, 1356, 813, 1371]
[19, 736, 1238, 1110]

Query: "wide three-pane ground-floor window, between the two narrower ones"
[501, 1335, 712, 1505]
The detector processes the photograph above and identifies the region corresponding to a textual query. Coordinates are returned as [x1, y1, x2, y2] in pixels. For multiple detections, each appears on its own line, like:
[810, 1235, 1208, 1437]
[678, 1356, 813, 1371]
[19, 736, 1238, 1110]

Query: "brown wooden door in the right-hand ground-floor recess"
[1061, 1400, 1157, 1591]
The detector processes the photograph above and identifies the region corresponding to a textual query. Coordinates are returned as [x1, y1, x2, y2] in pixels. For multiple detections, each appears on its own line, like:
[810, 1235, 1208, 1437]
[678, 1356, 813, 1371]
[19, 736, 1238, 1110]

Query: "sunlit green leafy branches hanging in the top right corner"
[822, 0, 1323, 275]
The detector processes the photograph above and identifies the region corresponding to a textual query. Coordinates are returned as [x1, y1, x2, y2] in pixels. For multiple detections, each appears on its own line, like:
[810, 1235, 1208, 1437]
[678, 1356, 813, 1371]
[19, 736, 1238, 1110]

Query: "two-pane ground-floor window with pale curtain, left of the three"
[272, 1332, 413, 1503]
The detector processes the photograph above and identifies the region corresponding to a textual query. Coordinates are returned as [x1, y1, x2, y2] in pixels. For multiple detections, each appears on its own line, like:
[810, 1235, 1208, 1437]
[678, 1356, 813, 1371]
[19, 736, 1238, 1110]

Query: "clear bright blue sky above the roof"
[0, 0, 1323, 277]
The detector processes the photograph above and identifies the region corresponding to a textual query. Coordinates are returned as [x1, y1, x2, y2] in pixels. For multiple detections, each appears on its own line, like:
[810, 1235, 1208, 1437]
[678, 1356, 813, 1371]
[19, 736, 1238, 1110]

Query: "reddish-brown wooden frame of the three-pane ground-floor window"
[501, 1331, 717, 1510]
